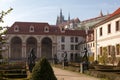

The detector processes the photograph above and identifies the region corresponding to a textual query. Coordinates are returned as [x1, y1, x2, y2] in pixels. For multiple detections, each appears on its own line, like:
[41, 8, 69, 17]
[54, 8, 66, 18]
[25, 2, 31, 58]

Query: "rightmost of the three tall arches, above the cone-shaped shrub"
[41, 37, 52, 59]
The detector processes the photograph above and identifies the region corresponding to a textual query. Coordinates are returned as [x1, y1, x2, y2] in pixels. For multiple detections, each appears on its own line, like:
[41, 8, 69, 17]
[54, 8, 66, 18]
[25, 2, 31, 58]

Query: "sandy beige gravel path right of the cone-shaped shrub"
[53, 67, 100, 80]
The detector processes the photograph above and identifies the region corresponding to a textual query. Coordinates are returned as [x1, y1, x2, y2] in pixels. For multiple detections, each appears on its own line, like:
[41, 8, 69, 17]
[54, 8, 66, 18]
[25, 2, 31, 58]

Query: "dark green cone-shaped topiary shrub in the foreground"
[31, 58, 57, 80]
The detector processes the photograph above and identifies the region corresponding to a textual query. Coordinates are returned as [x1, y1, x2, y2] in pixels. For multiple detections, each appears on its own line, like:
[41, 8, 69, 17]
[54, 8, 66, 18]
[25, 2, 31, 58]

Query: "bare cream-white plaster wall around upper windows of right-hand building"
[94, 17, 120, 57]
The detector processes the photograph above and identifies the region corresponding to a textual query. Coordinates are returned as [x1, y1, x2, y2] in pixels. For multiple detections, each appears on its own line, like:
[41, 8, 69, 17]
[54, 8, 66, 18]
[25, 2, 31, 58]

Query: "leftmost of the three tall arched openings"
[11, 37, 22, 59]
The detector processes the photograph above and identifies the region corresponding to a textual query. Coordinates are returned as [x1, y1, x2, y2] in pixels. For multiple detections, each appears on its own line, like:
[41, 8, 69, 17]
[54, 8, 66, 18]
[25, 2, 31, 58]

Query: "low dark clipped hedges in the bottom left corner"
[0, 61, 27, 80]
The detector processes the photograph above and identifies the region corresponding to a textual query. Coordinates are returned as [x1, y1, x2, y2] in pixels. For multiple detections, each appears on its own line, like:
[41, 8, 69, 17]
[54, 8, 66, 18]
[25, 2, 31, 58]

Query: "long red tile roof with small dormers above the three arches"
[7, 22, 85, 37]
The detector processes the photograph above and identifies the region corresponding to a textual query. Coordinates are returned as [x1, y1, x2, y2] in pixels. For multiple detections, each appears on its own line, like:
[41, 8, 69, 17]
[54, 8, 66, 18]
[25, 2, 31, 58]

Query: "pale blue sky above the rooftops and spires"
[0, 0, 120, 26]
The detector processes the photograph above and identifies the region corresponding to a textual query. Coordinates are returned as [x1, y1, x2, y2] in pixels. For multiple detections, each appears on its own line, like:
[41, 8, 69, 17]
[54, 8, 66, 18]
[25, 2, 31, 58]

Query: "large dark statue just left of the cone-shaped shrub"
[28, 48, 36, 72]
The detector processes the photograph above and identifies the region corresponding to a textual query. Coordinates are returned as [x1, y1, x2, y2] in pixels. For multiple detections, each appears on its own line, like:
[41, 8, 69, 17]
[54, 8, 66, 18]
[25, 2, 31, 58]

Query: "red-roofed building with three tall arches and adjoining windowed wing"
[4, 22, 85, 61]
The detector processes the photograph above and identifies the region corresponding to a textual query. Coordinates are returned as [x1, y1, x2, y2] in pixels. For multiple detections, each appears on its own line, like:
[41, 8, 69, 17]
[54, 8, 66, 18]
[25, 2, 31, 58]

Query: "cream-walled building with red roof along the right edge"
[94, 8, 120, 63]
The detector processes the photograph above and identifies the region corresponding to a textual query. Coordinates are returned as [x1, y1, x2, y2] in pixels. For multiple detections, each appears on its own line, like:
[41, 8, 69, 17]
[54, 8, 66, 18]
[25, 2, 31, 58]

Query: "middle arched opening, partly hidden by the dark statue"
[26, 37, 37, 57]
